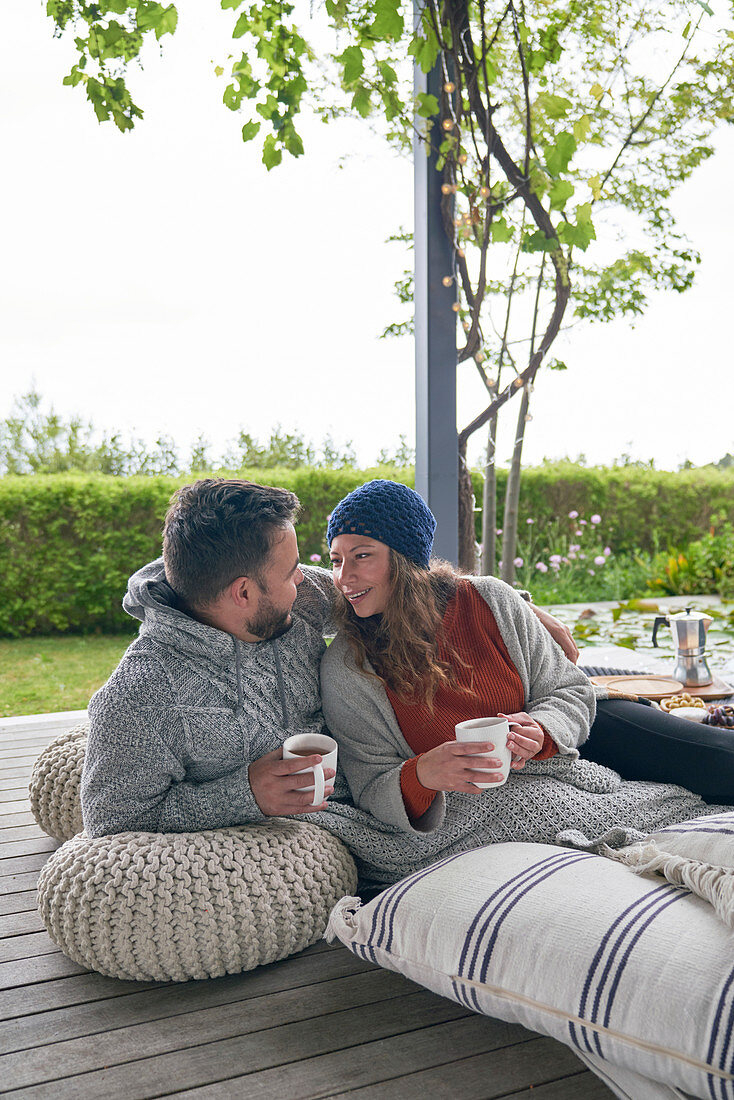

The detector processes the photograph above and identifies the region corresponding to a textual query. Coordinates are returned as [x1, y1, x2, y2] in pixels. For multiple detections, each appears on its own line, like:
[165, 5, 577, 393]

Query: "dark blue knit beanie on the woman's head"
[326, 479, 436, 569]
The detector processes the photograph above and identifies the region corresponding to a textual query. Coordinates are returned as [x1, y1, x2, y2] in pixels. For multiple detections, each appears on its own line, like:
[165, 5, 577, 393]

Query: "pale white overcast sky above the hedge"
[0, 0, 734, 469]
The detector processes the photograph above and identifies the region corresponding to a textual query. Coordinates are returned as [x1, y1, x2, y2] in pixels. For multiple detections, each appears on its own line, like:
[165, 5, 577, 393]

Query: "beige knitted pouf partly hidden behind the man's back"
[29, 723, 89, 840]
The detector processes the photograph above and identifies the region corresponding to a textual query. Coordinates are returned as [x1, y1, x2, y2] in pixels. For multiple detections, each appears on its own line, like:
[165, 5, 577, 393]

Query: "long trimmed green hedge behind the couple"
[0, 463, 734, 637]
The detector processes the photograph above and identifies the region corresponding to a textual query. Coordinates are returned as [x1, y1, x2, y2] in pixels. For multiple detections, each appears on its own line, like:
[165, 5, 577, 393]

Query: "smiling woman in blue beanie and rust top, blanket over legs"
[321, 481, 722, 854]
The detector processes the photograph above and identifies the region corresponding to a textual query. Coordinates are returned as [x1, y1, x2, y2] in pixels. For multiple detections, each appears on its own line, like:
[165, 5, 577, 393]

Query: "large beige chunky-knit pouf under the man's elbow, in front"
[39, 818, 357, 981]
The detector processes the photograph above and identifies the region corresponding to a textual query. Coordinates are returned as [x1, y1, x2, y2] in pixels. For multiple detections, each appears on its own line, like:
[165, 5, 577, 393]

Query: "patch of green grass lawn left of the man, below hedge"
[0, 634, 134, 718]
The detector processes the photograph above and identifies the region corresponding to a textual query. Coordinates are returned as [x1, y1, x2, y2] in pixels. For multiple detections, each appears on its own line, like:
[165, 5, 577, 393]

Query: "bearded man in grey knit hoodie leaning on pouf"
[81, 479, 585, 877]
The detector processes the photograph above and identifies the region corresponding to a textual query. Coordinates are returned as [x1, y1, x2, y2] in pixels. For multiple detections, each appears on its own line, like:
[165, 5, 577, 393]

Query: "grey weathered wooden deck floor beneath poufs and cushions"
[0, 721, 612, 1100]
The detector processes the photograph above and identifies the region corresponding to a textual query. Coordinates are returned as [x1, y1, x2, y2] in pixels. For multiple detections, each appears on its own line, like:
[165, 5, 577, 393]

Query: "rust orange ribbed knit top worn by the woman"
[386, 581, 557, 821]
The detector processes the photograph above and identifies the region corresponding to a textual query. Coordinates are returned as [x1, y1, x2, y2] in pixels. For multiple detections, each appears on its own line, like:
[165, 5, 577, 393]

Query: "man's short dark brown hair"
[163, 477, 299, 608]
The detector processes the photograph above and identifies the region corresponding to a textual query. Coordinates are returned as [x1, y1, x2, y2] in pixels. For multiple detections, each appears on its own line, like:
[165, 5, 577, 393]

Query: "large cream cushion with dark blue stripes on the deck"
[327, 844, 734, 1100]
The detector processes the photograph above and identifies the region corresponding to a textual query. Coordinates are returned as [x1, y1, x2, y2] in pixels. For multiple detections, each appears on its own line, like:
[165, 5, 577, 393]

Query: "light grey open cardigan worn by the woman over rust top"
[321, 576, 596, 832]
